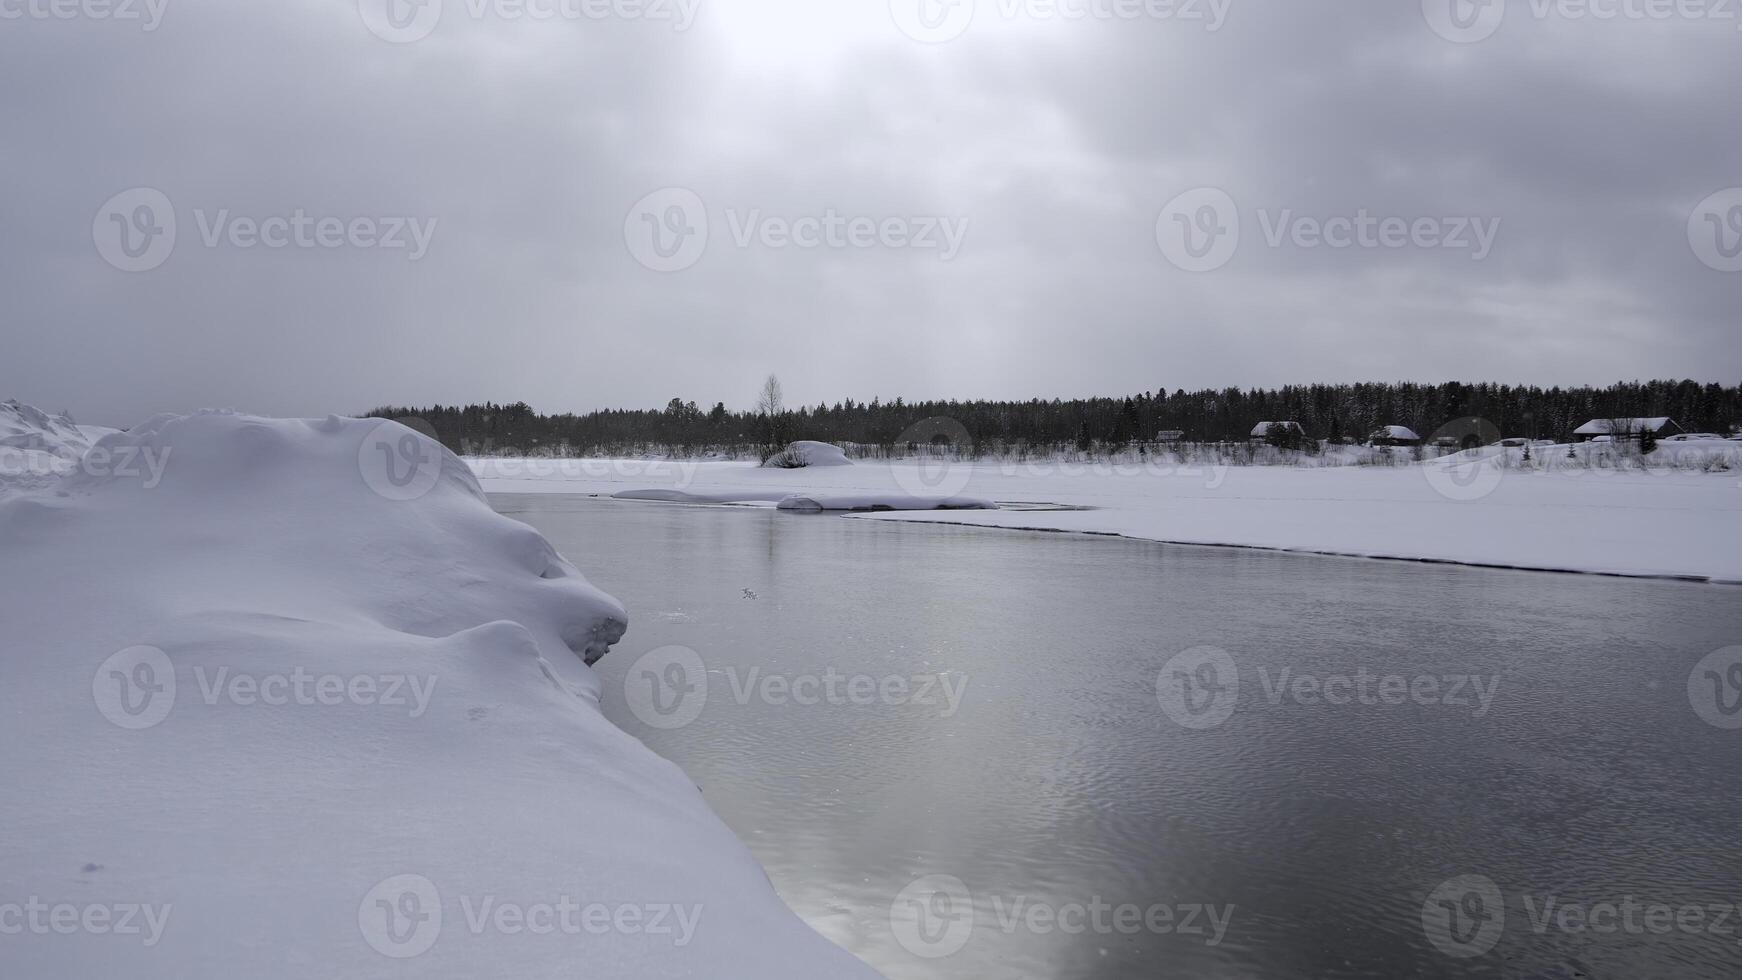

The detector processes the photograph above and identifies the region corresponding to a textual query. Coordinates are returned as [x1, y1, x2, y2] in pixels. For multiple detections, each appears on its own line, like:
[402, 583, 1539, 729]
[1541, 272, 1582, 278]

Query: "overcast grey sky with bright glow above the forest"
[0, 0, 1742, 423]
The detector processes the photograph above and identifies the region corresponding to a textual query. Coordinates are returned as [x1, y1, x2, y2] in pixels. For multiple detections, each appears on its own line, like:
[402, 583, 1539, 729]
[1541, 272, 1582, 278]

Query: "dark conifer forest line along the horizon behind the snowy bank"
[369, 378, 1742, 456]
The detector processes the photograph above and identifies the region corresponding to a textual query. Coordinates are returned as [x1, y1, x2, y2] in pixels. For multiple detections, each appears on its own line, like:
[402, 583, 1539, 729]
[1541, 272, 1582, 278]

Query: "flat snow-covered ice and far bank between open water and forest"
[469, 440, 1742, 583]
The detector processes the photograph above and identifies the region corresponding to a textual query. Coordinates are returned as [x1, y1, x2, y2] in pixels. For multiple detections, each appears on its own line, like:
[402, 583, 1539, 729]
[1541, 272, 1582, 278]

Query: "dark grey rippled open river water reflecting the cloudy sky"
[496, 496, 1742, 980]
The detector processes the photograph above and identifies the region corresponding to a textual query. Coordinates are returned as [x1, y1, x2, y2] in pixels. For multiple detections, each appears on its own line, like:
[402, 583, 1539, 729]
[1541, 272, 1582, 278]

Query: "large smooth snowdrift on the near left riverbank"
[0, 414, 871, 980]
